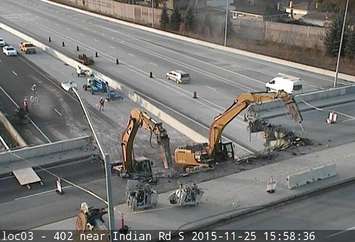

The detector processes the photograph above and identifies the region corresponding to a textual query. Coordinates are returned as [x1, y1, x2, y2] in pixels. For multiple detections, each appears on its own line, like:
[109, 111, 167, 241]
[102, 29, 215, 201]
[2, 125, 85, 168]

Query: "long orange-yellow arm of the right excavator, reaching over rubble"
[207, 91, 302, 156]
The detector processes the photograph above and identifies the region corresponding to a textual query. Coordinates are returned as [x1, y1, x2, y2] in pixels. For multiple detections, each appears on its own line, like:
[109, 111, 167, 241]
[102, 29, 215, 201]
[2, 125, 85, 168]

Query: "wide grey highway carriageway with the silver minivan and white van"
[0, 0, 354, 154]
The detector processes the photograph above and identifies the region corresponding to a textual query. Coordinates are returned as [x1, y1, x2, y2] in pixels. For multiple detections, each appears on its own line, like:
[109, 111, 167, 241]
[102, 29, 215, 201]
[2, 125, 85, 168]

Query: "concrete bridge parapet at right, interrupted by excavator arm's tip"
[248, 85, 355, 118]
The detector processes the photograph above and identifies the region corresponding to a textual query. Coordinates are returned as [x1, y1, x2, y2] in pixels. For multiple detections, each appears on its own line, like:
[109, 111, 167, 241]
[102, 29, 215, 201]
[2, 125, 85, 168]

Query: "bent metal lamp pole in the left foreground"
[72, 88, 115, 238]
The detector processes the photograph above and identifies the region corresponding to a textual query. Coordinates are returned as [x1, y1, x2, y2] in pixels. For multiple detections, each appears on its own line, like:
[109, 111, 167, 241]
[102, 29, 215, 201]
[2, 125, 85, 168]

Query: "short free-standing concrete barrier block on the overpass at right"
[287, 164, 336, 189]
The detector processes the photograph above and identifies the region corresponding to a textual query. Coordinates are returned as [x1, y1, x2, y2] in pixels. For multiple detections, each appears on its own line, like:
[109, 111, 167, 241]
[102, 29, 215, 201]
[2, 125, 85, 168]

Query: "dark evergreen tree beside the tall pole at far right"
[325, 14, 347, 56]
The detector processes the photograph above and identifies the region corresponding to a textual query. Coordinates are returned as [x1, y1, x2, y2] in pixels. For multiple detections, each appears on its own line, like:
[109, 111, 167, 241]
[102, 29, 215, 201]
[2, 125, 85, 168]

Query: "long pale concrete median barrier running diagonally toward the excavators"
[0, 22, 207, 143]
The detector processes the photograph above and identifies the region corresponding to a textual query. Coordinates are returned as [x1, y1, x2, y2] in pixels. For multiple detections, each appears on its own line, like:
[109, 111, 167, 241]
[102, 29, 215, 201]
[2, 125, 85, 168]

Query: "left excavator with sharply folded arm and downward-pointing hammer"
[113, 109, 173, 179]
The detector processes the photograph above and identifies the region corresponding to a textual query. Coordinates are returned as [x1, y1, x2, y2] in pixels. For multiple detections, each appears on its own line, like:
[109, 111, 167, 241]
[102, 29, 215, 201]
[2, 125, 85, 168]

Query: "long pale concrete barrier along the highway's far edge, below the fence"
[40, 0, 355, 82]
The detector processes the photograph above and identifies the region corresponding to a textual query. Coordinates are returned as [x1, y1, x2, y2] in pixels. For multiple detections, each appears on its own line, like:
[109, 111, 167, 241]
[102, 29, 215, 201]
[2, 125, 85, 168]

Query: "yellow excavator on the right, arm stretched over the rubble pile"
[175, 91, 302, 168]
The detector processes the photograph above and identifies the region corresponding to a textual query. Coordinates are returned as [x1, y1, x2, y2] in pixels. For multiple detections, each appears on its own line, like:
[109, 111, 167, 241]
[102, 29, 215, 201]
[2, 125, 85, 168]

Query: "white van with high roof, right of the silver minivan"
[265, 73, 303, 94]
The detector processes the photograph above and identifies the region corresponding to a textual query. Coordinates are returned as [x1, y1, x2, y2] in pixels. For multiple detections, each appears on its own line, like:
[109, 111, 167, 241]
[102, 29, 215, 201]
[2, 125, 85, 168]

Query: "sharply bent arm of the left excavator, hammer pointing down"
[121, 109, 172, 173]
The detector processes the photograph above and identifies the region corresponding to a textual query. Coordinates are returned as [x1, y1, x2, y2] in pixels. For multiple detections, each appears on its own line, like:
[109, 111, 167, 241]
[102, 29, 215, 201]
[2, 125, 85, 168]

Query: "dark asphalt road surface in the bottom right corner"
[211, 183, 355, 242]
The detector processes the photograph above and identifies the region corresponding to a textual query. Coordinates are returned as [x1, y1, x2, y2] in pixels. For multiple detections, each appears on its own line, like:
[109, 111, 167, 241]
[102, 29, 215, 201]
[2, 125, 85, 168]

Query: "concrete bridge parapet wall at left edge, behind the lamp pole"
[0, 136, 97, 174]
